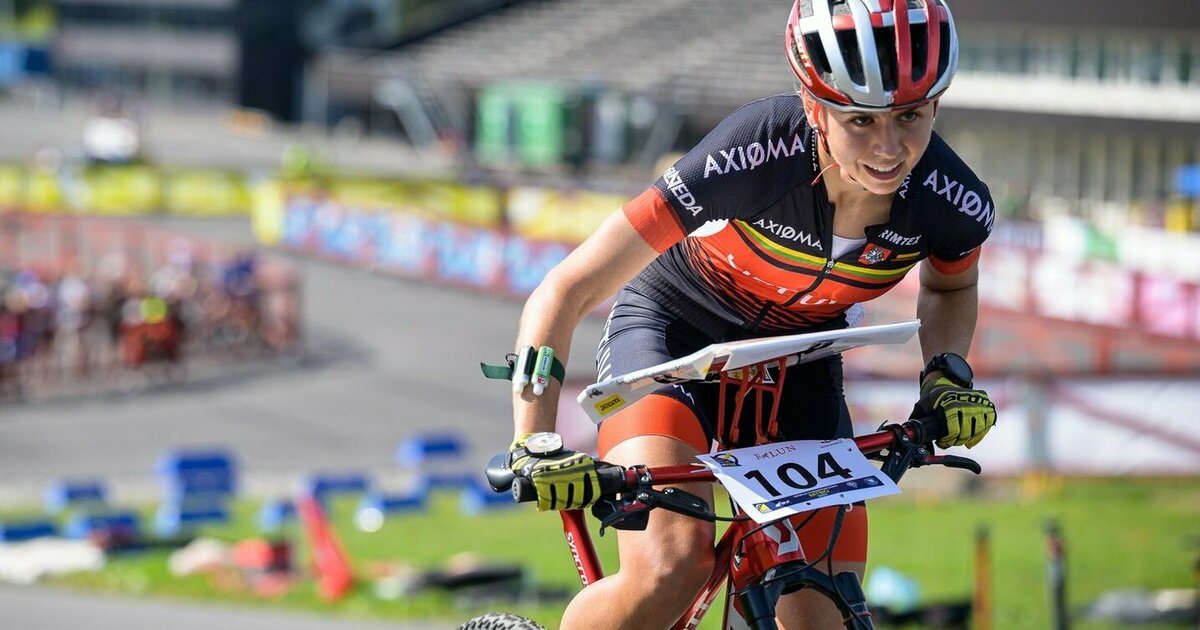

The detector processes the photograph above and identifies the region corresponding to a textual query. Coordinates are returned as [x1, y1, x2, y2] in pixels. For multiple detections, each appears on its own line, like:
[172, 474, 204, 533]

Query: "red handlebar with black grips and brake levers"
[487, 418, 980, 503]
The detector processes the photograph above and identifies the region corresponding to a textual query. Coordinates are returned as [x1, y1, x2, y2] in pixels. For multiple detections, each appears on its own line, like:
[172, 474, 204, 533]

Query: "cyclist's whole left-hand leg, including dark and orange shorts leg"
[563, 287, 714, 630]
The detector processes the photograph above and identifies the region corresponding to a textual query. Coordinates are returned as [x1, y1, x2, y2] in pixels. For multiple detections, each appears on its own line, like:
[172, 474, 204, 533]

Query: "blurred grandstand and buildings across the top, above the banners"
[0, 0, 1200, 195]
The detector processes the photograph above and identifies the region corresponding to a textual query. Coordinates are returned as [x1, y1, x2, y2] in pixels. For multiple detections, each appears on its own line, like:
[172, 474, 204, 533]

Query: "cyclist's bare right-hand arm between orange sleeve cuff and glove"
[917, 253, 979, 381]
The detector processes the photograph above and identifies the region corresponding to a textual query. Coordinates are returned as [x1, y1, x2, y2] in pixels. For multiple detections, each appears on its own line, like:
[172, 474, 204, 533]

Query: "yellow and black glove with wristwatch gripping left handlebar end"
[509, 433, 600, 511]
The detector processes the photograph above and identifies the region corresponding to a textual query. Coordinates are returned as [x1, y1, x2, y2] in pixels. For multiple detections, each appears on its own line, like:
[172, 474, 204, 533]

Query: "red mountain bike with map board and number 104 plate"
[461, 323, 980, 630]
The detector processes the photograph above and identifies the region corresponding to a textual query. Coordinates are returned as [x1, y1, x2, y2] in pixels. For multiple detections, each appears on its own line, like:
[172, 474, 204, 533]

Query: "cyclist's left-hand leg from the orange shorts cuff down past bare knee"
[562, 395, 714, 630]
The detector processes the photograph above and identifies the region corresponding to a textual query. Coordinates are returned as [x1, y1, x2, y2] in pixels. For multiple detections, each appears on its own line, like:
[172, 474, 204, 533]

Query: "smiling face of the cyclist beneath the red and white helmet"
[823, 103, 934, 194]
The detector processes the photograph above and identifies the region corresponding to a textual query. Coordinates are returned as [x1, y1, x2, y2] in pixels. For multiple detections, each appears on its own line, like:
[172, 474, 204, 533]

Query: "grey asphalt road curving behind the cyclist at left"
[0, 214, 601, 630]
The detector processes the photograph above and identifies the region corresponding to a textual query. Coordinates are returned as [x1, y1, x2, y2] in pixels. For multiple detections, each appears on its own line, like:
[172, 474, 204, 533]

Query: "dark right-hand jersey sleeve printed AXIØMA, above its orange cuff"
[900, 133, 995, 232]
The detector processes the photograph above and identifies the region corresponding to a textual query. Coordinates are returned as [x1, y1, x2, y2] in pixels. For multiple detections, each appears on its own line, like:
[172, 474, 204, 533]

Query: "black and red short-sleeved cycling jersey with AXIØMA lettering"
[624, 95, 995, 331]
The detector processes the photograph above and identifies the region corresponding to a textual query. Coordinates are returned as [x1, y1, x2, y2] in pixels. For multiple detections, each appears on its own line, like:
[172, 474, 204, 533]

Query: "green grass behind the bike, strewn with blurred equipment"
[8, 479, 1200, 630]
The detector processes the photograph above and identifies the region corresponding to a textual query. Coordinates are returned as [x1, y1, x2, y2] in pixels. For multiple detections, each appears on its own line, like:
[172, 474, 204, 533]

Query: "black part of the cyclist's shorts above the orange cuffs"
[596, 287, 853, 452]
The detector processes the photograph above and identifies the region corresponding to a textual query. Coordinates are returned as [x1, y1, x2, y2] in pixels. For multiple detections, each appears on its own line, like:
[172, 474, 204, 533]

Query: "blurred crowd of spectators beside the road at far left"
[0, 222, 299, 400]
